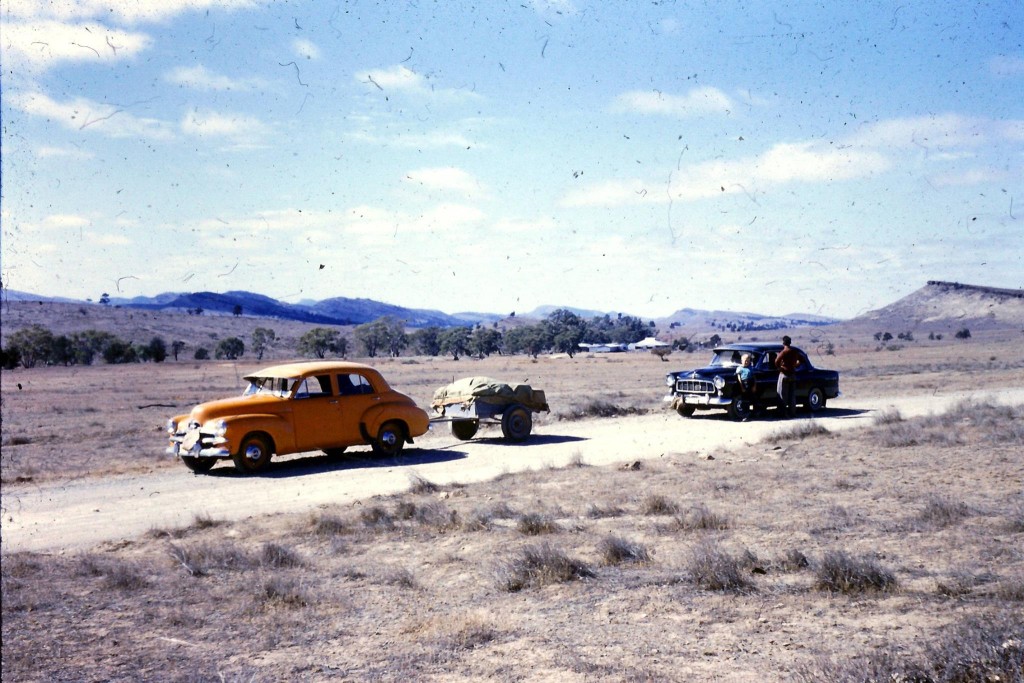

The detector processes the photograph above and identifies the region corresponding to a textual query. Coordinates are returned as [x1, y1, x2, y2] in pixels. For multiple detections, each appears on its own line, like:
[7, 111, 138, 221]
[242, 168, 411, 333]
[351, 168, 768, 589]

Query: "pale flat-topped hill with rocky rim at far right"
[850, 280, 1024, 330]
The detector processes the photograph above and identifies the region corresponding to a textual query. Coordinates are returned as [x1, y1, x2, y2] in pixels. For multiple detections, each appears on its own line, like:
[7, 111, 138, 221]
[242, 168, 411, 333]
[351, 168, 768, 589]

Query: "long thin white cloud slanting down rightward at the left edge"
[10, 92, 173, 140]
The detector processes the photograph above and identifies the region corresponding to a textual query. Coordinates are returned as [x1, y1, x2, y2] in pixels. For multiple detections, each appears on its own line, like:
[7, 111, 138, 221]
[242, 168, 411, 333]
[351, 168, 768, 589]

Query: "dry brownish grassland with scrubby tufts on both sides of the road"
[0, 333, 1024, 683]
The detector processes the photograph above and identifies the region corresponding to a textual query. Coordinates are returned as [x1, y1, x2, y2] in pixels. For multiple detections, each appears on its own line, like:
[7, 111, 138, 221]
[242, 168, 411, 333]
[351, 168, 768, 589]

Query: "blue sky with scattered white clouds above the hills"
[0, 0, 1024, 318]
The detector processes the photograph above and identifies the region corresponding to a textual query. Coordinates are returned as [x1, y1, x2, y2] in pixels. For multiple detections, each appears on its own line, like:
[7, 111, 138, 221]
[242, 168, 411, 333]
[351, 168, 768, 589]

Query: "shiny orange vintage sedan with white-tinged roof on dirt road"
[167, 361, 429, 473]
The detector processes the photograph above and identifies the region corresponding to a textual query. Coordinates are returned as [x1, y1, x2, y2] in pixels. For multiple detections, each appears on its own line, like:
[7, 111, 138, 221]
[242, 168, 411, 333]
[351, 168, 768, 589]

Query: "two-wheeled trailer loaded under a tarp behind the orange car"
[430, 377, 550, 442]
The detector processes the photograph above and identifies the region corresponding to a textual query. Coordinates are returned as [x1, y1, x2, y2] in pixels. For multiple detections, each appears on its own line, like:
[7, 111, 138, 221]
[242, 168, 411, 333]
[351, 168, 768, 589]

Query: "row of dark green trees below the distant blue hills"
[0, 309, 657, 370]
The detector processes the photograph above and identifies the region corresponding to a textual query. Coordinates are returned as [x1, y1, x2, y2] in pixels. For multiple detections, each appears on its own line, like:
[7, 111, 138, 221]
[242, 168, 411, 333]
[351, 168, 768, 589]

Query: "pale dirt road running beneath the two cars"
[2, 389, 1024, 552]
